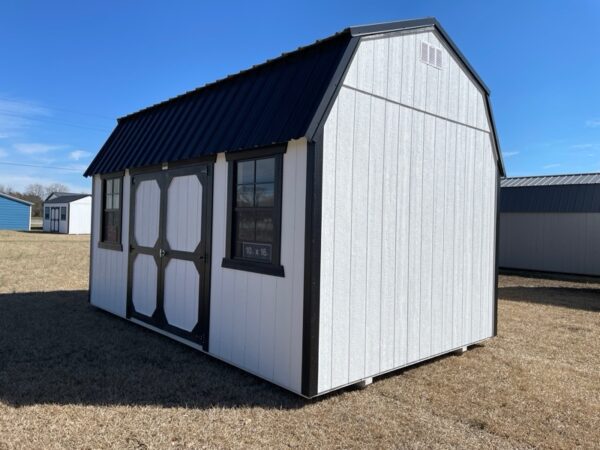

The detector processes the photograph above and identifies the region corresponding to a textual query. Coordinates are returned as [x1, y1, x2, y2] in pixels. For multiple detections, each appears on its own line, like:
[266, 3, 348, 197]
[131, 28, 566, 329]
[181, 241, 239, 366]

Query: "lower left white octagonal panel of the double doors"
[131, 253, 158, 317]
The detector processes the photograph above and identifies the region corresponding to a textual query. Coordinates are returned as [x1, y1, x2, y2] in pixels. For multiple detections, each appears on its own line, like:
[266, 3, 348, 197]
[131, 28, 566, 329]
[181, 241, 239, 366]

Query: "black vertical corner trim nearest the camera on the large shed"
[301, 131, 323, 397]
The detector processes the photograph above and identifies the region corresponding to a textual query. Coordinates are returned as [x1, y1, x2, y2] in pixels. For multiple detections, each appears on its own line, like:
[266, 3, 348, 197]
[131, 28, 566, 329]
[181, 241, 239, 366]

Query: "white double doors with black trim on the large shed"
[127, 164, 213, 351]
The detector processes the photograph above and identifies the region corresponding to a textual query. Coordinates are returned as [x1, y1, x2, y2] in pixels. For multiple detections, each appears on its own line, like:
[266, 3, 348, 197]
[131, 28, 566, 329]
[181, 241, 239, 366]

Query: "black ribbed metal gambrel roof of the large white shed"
[84, 18, 504, 176]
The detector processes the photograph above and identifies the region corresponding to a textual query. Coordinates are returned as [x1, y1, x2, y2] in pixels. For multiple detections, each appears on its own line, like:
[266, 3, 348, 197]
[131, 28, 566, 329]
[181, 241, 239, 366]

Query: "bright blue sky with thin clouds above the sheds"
[0, 0, 600, 191]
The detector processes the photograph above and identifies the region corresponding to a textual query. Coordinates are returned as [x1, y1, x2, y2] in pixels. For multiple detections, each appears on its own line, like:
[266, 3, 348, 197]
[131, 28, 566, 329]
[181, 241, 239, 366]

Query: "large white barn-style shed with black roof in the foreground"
[86, 19, 503, 397]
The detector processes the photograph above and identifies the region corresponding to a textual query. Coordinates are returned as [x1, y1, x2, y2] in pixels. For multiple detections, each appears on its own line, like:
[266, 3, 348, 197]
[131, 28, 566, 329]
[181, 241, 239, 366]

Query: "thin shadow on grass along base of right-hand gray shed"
[498, 286, 600, 311]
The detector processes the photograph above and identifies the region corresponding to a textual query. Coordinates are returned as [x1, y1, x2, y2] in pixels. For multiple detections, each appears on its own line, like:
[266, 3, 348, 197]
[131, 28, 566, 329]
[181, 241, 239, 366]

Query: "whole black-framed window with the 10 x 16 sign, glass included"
[223, 147, 285, 276]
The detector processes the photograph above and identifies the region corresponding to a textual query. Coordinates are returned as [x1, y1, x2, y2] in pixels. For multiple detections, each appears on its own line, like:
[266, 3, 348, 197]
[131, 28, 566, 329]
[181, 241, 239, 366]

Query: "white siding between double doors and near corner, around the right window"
[209, 140, 307, 392]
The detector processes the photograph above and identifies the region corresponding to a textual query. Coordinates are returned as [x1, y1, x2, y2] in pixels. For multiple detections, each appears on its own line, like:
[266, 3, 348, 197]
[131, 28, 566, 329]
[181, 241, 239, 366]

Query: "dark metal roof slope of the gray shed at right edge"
[500, 184, 600, 213]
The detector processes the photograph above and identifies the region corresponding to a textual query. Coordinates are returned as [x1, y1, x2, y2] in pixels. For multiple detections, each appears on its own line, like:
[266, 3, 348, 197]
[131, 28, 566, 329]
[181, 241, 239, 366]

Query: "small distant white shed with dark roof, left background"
[43, 192, 92, 234]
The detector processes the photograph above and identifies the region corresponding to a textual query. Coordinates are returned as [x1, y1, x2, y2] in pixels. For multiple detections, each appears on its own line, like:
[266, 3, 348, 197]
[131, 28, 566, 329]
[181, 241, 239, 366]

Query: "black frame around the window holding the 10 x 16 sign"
[221, 144, 287, 277]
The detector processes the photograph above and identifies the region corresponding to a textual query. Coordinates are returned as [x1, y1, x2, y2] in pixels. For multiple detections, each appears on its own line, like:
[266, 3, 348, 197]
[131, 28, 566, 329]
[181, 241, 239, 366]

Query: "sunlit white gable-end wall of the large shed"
[319, 29, 497, 392]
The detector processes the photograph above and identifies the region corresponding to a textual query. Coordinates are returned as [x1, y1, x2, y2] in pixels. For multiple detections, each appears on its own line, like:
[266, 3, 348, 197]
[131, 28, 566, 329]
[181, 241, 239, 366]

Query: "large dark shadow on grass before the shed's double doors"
[0, 291, 306, 409]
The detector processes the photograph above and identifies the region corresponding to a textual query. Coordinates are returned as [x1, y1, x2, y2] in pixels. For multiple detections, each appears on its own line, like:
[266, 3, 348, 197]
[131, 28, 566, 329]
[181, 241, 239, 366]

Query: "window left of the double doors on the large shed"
[100, 176, 122, 250]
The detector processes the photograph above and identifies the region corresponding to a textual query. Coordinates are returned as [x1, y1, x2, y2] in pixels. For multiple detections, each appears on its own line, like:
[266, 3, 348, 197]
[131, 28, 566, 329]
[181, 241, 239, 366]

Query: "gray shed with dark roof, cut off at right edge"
[499, 173, 600, 276]
